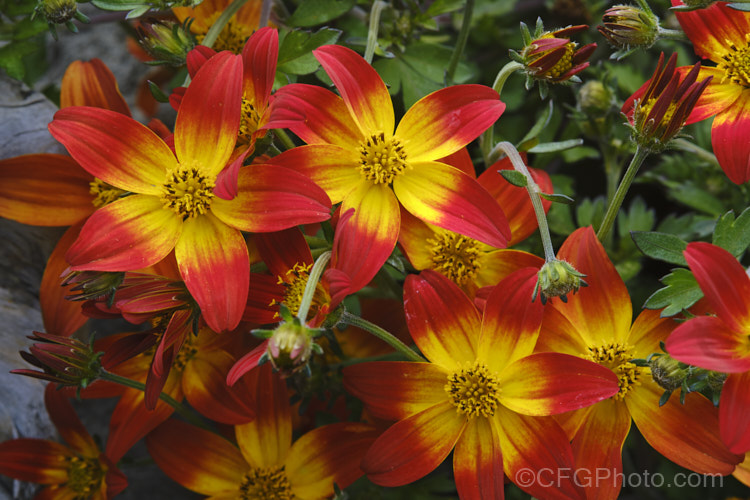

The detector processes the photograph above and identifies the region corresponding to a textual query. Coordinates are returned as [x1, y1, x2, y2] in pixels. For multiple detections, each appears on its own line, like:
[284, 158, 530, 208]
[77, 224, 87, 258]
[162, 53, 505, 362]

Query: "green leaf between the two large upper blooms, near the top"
[277, 28, 341, 75]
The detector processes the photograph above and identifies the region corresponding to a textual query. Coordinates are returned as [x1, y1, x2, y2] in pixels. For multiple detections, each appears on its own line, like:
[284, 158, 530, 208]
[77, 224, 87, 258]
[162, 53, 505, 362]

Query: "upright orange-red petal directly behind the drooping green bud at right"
[551, 227, 633, 345]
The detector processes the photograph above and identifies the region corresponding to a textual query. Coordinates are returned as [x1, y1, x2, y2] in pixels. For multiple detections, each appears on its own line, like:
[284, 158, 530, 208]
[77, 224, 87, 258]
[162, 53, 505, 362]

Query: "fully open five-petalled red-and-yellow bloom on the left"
[49, 52, 330, 332]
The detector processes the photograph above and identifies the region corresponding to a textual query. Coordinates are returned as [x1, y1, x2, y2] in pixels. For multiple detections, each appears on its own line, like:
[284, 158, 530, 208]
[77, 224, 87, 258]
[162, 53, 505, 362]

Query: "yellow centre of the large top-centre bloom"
[359, 132, 407, 184]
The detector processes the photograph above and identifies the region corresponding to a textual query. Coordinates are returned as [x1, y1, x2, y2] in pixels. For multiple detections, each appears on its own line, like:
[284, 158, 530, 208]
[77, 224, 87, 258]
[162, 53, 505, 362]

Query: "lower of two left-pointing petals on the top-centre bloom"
[260, 144, 363, 203]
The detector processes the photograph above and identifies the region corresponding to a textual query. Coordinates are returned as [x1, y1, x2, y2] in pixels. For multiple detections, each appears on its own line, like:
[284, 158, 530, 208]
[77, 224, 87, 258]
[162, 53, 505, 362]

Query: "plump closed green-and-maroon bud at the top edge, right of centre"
[597, 5, 659, 49]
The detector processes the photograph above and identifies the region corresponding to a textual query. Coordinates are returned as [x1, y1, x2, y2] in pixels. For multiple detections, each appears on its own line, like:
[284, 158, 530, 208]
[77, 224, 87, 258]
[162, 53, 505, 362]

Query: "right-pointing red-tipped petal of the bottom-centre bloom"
[500, 352, 619, 416]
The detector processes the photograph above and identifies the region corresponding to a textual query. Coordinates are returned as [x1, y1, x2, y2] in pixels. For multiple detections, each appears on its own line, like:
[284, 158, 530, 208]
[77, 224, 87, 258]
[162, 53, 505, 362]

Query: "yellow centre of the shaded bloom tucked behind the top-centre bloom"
[427, 231, 482, 285]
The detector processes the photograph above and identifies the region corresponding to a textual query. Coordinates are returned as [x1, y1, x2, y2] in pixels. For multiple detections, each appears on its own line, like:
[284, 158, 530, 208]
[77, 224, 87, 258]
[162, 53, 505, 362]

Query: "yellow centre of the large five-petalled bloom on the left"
[160, 165, 215, 220]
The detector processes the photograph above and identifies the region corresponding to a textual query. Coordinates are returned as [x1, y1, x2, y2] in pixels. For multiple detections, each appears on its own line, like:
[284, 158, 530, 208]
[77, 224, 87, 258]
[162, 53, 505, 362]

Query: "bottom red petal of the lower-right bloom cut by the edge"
[719, 372, 750, 454]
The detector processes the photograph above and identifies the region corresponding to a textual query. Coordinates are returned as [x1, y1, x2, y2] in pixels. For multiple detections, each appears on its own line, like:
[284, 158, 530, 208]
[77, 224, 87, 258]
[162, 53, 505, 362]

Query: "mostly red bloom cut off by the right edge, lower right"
[666, 242, 750, 453]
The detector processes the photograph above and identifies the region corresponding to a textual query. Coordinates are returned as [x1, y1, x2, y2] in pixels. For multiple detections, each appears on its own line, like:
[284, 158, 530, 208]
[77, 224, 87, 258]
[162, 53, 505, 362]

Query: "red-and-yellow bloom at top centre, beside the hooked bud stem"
[267, 45, 510, 290]
